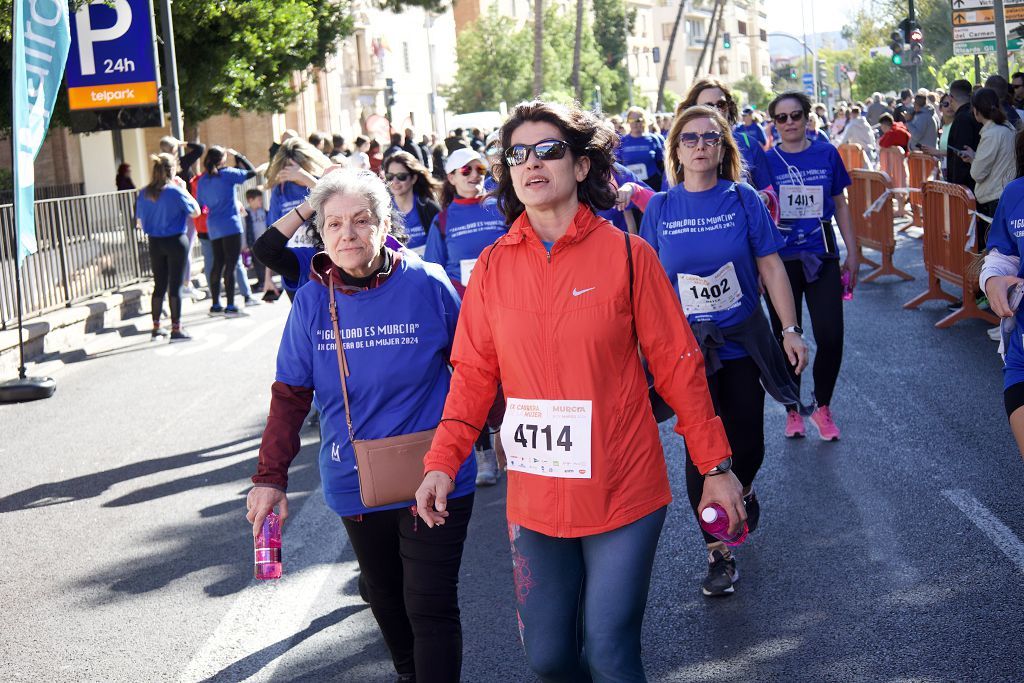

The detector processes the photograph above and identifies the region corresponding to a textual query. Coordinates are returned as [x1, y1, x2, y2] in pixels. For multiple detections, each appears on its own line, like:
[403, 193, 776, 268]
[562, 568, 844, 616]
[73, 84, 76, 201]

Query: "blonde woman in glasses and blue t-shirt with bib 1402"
[640, 105, 807, 596]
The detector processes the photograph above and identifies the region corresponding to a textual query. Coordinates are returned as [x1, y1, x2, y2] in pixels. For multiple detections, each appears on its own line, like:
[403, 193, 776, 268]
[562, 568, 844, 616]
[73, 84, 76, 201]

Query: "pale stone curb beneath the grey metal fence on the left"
[0, 282, 153, 381]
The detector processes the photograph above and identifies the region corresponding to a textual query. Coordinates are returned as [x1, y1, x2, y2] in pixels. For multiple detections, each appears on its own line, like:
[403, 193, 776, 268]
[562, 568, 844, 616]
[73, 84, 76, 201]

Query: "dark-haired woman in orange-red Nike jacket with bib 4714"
[416, 101, 745, 681]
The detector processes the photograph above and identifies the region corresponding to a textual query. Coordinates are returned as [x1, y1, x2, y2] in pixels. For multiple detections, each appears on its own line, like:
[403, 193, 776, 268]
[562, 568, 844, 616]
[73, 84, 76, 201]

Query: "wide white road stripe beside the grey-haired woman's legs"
[178, 489, 347, 683]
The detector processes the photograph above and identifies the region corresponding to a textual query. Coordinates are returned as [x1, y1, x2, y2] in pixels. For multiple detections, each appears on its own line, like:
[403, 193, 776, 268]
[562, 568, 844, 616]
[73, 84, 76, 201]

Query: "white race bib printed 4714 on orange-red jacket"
[502, 398, 594, 479]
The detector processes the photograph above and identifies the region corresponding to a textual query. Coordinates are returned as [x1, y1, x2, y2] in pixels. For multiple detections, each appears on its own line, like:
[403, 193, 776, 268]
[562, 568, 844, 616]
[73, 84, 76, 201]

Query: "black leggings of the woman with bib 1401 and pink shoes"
[765, 259, 843, 405]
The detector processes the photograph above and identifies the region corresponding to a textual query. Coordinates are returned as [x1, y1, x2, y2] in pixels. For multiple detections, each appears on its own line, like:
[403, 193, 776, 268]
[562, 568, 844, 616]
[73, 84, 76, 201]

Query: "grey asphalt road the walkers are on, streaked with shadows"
[0, 229, 1024, 682]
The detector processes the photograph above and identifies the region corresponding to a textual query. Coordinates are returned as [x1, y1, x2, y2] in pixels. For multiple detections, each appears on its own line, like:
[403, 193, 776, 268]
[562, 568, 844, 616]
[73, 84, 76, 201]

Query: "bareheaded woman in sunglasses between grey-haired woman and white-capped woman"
[384, 152, 441, 255]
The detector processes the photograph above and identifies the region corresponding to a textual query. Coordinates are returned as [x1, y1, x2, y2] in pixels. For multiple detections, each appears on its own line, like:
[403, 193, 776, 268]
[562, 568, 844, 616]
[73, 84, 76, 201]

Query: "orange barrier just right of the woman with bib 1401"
[847, 169, 913, 283]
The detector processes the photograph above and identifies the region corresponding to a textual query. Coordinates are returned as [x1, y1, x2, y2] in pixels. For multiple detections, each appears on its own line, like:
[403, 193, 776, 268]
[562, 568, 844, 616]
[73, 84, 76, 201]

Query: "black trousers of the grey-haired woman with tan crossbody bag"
[343, 494, 473, 683]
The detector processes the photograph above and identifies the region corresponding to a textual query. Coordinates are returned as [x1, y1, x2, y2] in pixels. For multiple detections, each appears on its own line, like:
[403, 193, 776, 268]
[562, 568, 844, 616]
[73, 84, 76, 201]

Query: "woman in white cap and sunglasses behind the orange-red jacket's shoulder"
[423, 147, 508, 486]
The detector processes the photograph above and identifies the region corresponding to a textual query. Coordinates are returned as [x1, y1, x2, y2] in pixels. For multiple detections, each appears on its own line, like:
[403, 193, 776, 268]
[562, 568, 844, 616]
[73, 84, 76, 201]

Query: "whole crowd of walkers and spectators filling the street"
[125, 69, 1024, 683]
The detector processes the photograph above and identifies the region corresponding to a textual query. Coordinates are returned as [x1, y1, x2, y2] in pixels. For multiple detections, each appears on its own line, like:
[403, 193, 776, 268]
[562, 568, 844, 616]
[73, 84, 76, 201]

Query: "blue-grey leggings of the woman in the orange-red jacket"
[509, 508, 667, 683]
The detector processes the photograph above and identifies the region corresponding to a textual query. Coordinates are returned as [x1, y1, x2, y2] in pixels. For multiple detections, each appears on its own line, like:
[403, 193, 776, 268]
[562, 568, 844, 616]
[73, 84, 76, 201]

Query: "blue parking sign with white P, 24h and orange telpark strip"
[67, 0, 160, 111]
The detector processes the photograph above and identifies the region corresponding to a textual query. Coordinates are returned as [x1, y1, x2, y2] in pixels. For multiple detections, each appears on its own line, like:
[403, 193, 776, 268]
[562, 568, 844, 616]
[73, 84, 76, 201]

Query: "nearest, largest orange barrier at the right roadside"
[903, 180, 999, 329]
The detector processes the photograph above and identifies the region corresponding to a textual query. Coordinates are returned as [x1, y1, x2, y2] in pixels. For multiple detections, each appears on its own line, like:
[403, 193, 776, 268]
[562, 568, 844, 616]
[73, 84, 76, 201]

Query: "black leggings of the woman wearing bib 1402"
[686, 357, 765, 543]
